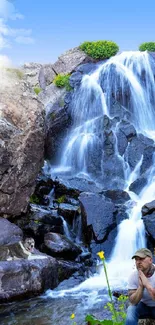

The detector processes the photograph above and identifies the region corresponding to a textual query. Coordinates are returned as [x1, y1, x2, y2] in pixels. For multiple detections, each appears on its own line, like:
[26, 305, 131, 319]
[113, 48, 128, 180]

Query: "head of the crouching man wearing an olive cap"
[132, 248, 152, 273]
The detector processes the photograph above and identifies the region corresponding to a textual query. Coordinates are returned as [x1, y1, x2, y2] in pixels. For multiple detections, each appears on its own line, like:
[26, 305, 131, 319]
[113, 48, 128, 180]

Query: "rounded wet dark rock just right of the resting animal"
[43, 232, 82, 260]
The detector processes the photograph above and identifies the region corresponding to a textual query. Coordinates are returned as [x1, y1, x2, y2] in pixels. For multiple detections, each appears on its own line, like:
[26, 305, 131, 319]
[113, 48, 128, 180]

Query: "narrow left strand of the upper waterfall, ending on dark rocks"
[60, 75, 108, 174]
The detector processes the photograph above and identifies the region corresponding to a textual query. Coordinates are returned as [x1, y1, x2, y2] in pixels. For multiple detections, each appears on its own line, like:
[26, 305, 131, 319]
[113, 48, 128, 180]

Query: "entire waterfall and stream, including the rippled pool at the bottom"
[2, 52, 155, 325]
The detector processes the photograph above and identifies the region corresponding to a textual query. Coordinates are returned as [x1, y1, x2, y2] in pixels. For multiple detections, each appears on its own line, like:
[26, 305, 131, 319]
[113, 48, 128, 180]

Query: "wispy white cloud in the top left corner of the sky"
[0, 0, 34, 50]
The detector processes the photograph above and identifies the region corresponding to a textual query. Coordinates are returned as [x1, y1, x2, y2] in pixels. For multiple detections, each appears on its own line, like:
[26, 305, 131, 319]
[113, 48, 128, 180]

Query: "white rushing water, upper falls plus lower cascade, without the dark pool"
[45, 52, 155, 297]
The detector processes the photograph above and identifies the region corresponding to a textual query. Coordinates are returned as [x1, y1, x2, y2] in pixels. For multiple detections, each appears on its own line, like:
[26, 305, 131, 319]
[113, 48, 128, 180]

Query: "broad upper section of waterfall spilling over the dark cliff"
[51, 52, 155, 180]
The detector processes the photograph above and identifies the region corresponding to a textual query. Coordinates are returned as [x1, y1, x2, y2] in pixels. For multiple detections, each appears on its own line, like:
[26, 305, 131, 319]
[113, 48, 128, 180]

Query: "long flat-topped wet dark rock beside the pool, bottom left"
[0, 256, 58, 303]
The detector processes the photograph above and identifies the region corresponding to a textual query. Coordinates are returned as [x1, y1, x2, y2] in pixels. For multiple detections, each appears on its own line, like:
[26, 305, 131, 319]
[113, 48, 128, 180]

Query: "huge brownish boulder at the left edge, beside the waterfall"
[0, 70, 44, 216]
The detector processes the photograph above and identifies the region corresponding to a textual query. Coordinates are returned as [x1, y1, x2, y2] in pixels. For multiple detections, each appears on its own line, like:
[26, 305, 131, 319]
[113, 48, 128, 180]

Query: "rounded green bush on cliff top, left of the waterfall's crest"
[79, 41, 119, 60]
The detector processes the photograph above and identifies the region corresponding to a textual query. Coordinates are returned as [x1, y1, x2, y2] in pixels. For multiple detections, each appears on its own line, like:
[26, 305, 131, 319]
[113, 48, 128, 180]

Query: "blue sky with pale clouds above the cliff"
[0, 0, 155, 65]
